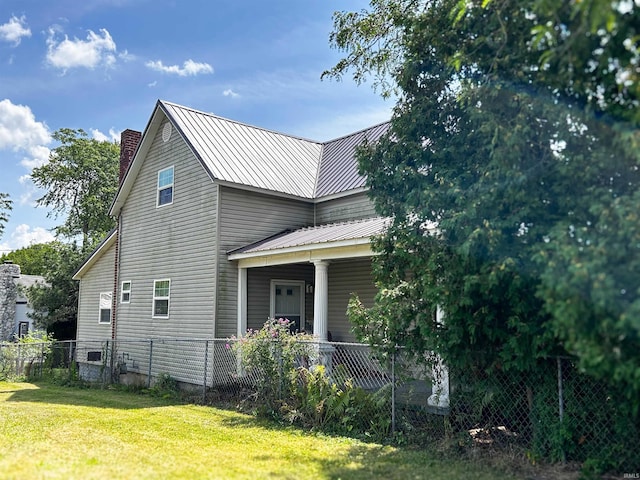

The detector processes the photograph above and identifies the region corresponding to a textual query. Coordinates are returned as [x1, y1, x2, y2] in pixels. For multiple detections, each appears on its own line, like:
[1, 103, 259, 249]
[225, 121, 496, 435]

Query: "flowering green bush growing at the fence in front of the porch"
[233, 318, 391, 439]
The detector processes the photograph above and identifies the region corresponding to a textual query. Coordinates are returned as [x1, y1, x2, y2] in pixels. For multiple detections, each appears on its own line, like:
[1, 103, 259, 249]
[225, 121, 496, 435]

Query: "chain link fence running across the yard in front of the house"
[0, 339, 640, 472]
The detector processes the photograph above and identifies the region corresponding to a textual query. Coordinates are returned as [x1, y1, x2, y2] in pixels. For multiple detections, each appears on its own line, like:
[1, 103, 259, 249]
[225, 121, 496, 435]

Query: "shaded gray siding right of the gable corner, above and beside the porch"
[216, 187, 313, 338]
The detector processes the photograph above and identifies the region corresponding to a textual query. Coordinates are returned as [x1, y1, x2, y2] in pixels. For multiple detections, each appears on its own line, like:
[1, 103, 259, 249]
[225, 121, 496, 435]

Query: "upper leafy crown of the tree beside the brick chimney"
[31, 128, 119, 248]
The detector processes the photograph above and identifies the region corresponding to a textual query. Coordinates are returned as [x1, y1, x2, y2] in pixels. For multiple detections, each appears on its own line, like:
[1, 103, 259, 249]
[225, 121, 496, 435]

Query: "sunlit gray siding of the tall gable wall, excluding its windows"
[117, 120, 217, 339]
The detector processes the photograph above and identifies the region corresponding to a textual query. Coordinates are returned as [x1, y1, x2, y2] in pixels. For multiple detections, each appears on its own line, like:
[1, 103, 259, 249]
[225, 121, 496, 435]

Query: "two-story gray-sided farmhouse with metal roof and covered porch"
[74, 101, 388, 378]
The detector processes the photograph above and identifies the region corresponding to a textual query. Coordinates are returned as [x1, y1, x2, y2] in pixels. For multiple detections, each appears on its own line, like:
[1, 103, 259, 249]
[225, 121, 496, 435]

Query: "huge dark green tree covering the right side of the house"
[332, 0, 640, 395]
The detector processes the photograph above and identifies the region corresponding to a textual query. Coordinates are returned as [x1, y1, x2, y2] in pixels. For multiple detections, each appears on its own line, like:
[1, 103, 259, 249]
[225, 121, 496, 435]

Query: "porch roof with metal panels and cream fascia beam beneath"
[228, 217, 390, 268]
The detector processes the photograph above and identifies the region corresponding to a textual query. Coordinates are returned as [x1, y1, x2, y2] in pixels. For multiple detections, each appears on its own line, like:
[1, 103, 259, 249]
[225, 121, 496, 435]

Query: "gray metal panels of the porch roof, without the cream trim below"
[228, 217, 389, 255]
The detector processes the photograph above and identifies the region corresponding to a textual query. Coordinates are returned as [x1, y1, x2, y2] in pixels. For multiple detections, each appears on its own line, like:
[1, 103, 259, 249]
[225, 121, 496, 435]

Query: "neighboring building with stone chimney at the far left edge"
[0, 262, 44, 341]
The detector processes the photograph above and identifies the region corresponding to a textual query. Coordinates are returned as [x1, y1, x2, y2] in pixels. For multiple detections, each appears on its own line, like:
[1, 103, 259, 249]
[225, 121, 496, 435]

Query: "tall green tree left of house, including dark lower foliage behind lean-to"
[28, 128, 119, 338]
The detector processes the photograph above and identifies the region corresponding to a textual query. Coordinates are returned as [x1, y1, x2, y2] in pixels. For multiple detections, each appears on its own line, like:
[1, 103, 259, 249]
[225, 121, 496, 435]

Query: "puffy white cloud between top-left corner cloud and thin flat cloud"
[47, 28, 116, 71]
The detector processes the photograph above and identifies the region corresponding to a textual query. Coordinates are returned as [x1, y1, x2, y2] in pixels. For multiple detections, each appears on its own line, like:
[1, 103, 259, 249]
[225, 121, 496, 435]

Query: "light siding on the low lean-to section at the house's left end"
[76, 245, 115, 340]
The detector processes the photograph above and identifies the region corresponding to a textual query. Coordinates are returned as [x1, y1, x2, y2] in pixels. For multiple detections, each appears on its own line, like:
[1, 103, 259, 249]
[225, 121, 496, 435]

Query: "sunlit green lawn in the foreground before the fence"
[0, 382, 516, 480]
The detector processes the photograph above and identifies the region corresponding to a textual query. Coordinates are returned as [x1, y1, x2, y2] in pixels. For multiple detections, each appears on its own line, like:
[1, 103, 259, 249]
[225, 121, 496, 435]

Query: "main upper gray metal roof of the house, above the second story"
[158, 101, 389, 199]
